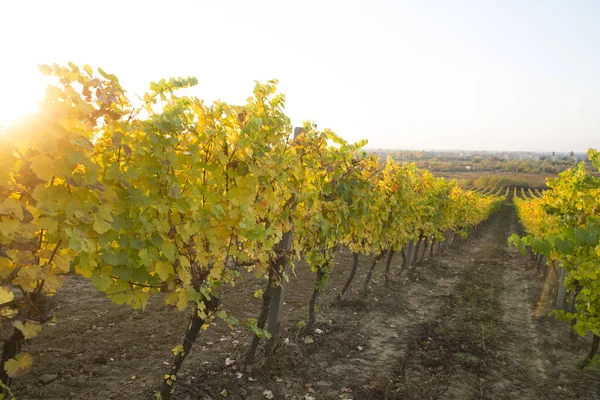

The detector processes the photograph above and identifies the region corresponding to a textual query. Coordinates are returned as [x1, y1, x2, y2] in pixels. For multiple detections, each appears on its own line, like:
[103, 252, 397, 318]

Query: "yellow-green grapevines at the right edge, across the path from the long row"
[510, 149, 600, 366]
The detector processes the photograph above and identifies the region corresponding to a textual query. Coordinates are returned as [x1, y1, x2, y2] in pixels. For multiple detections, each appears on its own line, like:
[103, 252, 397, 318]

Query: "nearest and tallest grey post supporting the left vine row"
[265, 127, 302, 356]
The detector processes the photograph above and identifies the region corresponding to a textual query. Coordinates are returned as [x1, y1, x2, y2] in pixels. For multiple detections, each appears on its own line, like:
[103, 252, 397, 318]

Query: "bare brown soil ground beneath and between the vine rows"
[10, 204, 600, 400]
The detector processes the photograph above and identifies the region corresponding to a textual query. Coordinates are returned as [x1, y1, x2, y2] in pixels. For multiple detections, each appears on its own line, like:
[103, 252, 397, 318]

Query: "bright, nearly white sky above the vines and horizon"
[0, 0, 600, 151]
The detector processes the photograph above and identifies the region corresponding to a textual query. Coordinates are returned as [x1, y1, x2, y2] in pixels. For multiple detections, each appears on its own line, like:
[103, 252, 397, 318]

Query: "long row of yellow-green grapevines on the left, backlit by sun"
[0, 64, 508, 399]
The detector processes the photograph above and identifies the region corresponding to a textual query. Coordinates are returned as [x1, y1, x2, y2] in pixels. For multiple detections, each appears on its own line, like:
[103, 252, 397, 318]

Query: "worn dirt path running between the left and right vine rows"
[356, 205, 600, 399]
